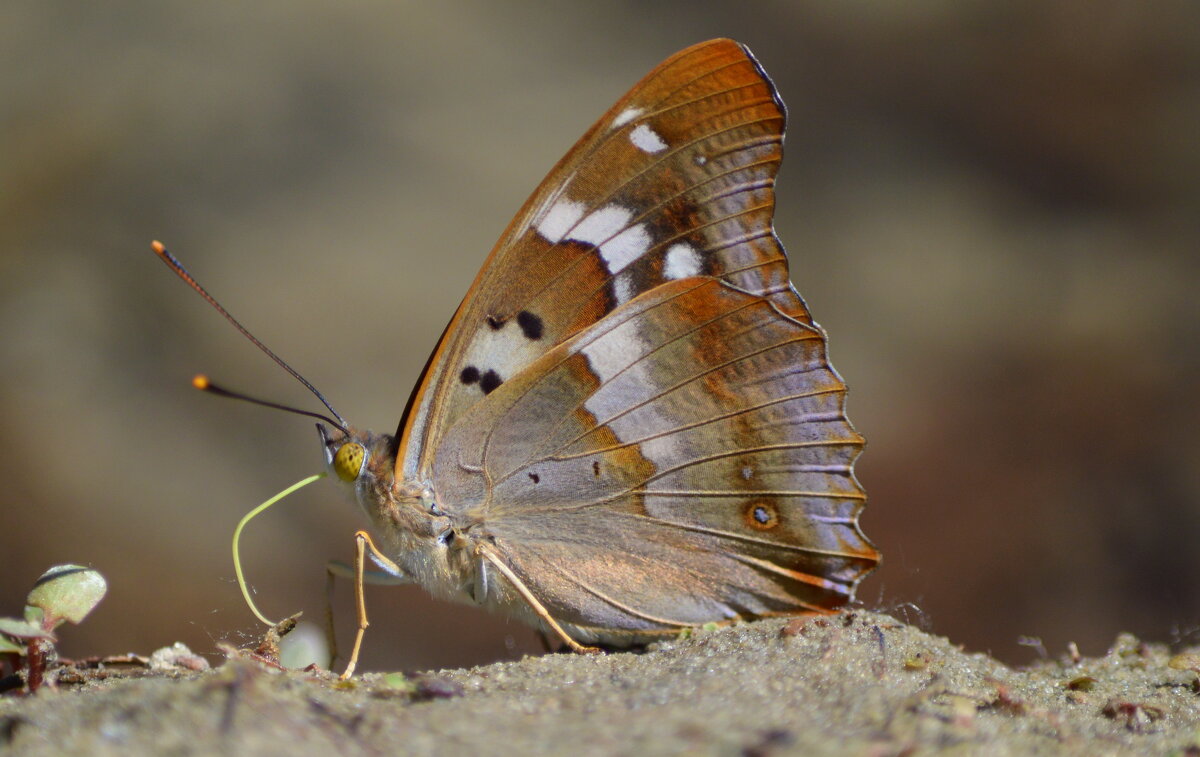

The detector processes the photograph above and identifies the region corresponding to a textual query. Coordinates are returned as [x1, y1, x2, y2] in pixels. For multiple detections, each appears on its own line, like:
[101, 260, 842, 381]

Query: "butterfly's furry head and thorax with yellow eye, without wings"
[320, 426, 475, 601]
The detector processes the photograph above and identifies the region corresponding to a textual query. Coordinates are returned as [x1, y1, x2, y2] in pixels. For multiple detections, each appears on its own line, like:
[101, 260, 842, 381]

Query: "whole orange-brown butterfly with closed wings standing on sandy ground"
[159, 40, 880, 671]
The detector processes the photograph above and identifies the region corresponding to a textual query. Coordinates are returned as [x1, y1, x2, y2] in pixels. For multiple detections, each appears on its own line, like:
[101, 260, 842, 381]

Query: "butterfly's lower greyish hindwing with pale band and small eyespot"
[433, 278, 877, 633]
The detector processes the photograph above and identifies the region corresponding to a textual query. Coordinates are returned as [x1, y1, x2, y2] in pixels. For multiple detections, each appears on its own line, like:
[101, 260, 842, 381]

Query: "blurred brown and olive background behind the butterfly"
[0, 0, 1200, 668]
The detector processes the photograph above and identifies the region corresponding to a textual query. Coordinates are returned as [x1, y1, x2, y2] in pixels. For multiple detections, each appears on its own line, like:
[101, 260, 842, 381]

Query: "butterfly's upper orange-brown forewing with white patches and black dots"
[396, 40, 810, 481]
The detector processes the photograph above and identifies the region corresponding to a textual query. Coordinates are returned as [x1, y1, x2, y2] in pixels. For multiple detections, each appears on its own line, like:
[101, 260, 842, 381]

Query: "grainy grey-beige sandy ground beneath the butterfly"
[0, 612, 1200, 755]
